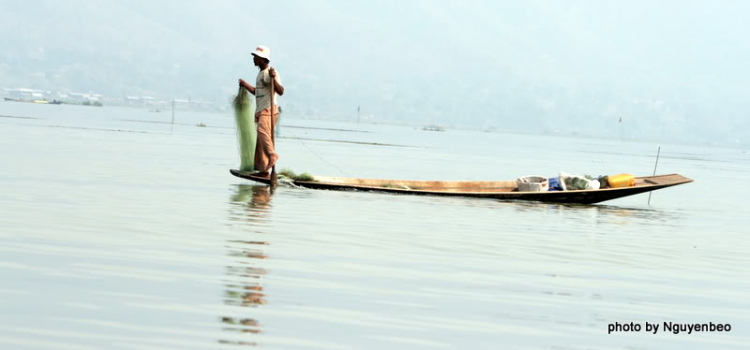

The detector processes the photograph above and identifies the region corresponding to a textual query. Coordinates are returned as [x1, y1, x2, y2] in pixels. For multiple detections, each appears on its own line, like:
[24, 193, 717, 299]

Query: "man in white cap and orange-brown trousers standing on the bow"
[240, 45, 284, 176]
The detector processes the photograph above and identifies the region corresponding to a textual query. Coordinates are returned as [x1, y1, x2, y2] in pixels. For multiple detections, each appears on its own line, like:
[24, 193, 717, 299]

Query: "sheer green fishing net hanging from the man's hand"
[233, 87, 257, 171]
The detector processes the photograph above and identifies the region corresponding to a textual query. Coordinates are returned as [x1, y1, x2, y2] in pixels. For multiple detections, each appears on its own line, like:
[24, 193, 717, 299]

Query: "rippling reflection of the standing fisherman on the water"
[219, 185, 273, 346]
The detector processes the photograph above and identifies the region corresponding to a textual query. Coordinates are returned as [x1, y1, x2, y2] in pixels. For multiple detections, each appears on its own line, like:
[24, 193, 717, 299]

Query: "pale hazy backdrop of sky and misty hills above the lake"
[0, 0, 750, 143]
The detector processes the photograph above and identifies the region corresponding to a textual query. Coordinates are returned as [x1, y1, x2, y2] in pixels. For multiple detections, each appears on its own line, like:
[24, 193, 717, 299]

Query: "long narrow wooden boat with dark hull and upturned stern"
[230, 169, 693, 204]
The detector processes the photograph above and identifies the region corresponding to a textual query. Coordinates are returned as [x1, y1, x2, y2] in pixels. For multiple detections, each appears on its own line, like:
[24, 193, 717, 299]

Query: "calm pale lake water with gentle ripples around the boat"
[0, 102, 750, 349]
